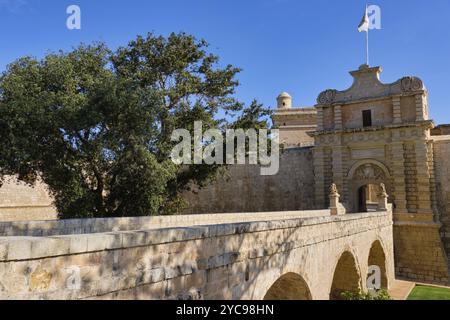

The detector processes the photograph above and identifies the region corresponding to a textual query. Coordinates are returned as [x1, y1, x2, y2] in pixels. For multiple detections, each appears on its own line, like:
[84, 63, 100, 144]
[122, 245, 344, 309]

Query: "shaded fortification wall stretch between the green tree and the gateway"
[181, 148, 314, 213]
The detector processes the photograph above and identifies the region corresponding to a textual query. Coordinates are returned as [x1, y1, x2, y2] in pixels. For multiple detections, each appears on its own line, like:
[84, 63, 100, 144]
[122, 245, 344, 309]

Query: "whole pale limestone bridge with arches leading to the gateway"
[0, 207, 394, 300]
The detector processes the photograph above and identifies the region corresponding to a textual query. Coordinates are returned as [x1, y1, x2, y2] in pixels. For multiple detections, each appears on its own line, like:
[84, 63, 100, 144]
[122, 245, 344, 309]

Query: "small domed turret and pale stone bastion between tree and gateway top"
[272, 92, 317, 148]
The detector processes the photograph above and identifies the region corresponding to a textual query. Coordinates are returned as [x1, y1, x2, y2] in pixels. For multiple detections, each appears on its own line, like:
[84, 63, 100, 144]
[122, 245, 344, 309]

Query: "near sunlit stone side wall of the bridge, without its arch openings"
[0, 210, 393, 299]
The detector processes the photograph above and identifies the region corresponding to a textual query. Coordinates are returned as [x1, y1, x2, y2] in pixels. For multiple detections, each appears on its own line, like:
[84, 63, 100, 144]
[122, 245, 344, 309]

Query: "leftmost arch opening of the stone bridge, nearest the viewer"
[264, 272, 312, 300]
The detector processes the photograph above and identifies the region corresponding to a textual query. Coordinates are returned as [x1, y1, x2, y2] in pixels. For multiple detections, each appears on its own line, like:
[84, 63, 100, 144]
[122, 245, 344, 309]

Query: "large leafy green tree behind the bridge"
[0, 33, 268, 218]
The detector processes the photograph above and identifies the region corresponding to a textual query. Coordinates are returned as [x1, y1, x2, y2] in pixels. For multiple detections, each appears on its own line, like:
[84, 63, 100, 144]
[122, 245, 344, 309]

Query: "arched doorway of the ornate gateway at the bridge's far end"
[347, 159, 392, 212]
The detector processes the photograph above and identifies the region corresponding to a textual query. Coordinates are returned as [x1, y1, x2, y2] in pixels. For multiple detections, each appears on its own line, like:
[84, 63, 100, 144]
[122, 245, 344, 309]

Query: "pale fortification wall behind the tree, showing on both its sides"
[0, 147, 314, 221]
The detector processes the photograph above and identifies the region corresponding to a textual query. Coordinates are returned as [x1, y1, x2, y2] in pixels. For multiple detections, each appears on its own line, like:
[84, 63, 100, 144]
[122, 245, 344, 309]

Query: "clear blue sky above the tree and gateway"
[0, 0, 450, 124]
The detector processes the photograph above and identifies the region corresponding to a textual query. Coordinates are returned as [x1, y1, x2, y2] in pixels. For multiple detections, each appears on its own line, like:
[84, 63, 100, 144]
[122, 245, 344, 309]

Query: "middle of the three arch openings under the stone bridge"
[330, 251, 361, 300]
